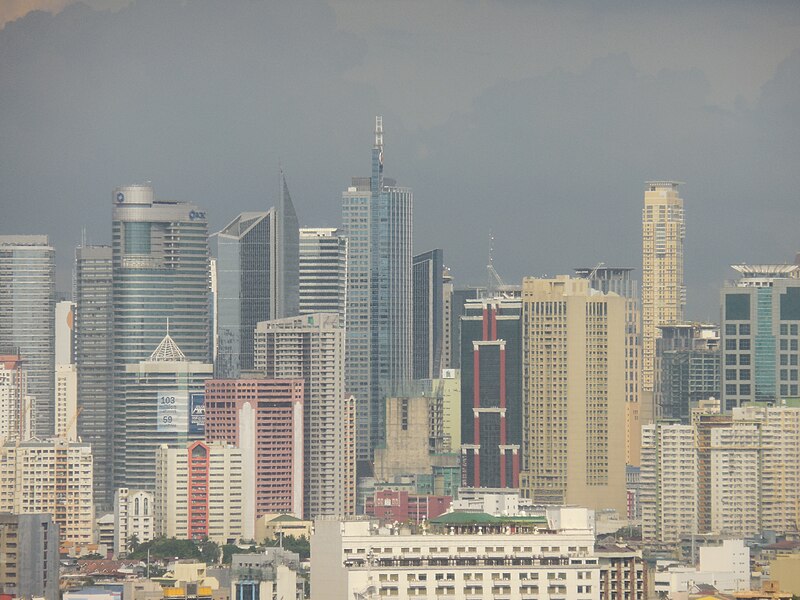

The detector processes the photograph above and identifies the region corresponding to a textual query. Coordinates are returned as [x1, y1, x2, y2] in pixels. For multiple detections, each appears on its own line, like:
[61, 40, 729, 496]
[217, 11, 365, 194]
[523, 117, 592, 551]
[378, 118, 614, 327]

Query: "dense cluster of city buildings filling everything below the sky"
[0, 117, 800, 600]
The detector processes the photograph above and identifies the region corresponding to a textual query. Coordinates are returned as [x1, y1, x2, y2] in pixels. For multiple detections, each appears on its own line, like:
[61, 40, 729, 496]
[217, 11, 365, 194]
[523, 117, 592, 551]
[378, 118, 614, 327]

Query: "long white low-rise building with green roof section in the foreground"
[311, 508, 600, 600]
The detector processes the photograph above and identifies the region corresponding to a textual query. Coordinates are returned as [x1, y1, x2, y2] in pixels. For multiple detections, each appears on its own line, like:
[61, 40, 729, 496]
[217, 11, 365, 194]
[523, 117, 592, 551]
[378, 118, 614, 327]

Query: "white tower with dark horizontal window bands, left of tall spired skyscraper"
[300, 227, 347, 327]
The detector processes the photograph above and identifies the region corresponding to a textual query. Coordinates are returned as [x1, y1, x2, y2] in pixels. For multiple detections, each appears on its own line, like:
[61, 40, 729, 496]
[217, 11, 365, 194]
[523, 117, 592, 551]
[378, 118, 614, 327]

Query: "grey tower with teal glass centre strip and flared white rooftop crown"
[721, 265, 800, 411]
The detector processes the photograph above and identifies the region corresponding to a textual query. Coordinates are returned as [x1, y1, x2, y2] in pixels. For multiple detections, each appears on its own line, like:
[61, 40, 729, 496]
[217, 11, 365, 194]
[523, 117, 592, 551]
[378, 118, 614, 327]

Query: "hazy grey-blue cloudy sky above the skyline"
[0, 0, 800, 321]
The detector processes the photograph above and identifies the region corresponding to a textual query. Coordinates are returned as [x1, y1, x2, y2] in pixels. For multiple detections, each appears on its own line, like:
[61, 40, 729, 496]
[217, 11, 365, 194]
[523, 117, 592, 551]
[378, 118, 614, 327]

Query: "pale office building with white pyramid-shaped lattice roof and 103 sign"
[117, 333, 214, 491]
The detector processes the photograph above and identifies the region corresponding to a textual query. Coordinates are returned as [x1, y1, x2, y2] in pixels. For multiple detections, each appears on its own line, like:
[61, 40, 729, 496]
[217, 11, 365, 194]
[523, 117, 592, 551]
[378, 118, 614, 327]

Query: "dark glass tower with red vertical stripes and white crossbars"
[460, 298, 522, 488]
